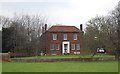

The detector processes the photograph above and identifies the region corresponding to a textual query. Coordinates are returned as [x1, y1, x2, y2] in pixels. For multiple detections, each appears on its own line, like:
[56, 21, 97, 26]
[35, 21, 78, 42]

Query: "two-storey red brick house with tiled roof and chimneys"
[40, 25, 83, 55]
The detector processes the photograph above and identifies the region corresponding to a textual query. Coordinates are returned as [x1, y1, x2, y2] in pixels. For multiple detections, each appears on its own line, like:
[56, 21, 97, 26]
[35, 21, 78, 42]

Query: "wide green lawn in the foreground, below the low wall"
[2, 61, 118, 72]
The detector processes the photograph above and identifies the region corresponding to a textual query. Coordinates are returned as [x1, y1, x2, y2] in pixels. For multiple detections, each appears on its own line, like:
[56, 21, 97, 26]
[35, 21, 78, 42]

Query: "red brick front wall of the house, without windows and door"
[44, 32, 84, 55]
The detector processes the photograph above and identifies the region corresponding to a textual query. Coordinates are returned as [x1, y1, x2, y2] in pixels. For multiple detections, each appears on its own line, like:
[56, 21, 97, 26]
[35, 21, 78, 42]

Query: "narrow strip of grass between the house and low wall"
[15, 54, 115, 59]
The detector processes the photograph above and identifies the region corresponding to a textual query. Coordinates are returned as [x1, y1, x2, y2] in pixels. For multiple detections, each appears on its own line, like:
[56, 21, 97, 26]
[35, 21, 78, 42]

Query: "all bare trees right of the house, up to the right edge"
[84, 3, 120, 54]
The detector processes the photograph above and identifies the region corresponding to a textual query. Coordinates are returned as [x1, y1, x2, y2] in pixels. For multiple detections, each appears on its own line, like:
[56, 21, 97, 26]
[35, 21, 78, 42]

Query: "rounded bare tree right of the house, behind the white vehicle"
[85, 16, 117, 54]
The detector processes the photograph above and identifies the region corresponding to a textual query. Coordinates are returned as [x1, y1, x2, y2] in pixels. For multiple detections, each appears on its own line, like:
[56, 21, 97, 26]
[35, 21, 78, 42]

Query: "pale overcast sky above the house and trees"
[0, 0, 119, 28]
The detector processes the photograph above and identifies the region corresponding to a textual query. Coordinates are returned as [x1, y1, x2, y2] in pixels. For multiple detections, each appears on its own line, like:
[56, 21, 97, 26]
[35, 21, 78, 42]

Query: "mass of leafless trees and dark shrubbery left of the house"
[0, 15, 46, 54]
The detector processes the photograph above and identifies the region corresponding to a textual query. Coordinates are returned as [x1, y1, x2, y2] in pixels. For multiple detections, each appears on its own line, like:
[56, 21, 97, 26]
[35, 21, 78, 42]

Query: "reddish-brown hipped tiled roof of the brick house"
[48, 26, 80, 32]
